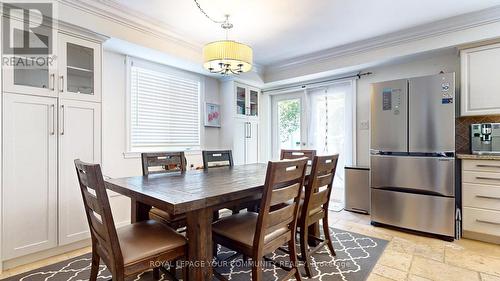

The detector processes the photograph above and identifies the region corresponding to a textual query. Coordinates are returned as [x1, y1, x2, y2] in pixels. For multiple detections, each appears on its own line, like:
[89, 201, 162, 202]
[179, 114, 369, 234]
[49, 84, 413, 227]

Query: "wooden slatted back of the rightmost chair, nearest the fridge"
[300, 154, 339, 224]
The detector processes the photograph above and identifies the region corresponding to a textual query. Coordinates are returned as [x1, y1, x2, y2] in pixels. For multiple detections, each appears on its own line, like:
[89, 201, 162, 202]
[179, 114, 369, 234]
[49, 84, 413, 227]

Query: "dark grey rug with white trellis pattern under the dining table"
[4, 228, 388, 281]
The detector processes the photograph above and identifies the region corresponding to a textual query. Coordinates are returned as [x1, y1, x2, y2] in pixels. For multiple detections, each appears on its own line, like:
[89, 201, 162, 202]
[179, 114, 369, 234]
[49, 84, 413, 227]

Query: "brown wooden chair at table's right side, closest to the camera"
[212, 158, 307, 281]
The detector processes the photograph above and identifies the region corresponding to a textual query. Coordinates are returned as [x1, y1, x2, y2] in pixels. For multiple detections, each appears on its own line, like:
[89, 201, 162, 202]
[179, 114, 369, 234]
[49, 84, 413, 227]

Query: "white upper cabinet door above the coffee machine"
[460, 44, 500, 116]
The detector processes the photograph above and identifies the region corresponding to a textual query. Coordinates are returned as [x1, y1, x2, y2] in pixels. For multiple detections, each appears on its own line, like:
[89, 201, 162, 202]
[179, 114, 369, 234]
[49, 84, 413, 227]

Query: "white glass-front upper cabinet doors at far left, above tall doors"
[3, 33, 101, 102]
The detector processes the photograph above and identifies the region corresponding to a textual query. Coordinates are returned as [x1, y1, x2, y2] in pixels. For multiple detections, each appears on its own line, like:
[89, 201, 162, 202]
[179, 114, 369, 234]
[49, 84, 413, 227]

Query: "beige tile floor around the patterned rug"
[0, 211, 500, 281]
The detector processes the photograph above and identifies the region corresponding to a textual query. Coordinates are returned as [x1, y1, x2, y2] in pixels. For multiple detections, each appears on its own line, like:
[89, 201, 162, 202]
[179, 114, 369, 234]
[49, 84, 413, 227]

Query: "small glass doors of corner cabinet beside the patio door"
[235, 84, 260, 118]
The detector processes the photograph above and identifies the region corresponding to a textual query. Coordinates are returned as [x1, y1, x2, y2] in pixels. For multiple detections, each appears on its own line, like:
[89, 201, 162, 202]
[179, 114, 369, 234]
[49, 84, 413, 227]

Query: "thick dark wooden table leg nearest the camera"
[187, 208, 213, 281]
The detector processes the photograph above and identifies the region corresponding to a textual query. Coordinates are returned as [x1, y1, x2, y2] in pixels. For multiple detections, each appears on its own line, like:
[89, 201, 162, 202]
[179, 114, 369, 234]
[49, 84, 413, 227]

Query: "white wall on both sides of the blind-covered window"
[102, 51, 220, 178]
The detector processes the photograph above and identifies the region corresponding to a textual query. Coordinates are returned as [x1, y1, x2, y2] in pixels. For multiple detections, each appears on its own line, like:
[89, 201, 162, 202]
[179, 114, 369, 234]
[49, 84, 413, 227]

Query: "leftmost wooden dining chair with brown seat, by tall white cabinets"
[75, 159, 187, 281]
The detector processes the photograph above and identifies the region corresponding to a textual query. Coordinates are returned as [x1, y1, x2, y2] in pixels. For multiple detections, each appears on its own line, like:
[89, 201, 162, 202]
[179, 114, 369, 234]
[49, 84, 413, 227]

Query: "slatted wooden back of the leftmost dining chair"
[75, 159, 123, 271]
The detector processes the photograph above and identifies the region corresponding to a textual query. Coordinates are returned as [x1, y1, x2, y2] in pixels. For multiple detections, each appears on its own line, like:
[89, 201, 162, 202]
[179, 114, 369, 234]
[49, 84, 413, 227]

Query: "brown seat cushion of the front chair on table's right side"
[212, 212, 288, 248]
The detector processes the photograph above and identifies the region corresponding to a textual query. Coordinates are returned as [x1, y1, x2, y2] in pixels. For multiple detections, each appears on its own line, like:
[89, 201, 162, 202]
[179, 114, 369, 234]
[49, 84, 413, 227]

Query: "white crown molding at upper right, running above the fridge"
[264, 5, 500, 73]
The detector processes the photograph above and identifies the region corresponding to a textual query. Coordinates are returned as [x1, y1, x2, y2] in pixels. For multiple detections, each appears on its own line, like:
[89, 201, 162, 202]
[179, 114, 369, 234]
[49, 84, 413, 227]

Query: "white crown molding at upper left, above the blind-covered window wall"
[58, 0, 203, 52]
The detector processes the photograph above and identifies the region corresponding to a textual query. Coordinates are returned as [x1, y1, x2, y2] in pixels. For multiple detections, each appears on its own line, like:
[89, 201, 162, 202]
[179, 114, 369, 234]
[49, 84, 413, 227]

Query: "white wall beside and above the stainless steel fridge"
[356, 51, 460, 165]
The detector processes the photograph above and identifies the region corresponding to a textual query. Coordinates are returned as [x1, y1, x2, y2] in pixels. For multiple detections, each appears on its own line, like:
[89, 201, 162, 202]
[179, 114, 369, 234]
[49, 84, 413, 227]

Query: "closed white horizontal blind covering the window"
[130, 65, 200, 151]
